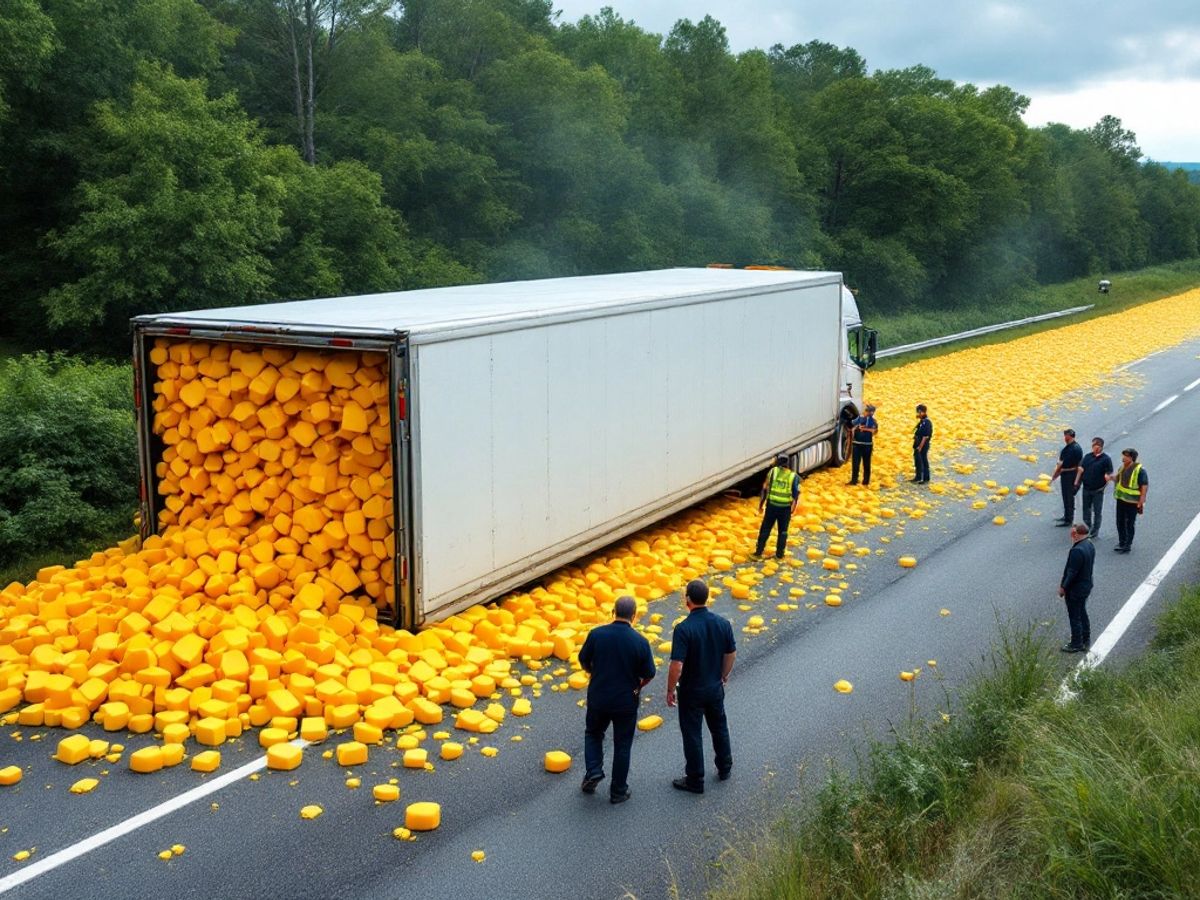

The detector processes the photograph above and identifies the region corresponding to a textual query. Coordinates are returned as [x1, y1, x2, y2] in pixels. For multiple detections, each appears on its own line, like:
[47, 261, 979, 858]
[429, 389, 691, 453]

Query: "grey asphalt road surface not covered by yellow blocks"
[7, 342, 1200, 900]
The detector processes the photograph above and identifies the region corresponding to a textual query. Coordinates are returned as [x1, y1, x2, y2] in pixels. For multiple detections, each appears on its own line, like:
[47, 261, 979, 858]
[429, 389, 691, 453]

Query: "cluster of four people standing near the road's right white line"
[1050, 428, 1150, 653]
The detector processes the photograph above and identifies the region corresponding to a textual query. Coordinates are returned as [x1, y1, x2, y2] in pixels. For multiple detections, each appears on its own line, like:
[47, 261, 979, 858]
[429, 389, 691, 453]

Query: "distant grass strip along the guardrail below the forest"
[863, 259, 1200, 371]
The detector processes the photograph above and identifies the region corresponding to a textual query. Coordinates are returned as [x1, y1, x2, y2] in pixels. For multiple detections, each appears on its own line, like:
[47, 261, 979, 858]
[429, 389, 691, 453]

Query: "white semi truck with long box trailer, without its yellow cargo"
[133, 268, 875, 628]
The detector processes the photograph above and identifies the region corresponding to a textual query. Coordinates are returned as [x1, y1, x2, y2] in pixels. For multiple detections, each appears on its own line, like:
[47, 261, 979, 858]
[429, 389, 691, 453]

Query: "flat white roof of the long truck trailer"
[134, 269, 841, 336]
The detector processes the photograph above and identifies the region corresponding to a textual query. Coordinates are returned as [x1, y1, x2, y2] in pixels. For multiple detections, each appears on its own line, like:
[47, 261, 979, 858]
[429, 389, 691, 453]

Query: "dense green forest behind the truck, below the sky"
[0, 0, 1200, 356]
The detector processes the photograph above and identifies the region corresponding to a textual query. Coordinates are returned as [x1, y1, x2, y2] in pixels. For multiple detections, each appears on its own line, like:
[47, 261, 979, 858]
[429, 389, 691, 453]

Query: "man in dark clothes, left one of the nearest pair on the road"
[580, 596, 654, 803]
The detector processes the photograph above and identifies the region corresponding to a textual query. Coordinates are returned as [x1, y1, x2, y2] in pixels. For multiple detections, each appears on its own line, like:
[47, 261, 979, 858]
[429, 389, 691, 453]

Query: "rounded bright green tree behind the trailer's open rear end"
[43, 62, 284, 335]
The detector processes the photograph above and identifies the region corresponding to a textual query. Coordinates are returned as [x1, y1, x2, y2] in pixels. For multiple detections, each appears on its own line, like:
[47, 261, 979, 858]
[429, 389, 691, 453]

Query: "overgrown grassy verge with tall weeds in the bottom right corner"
[710, 588, 1200, 900]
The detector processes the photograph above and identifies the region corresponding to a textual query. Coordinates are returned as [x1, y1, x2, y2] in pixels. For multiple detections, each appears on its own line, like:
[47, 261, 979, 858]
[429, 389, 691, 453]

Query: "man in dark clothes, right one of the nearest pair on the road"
[667, 578, 737, 793]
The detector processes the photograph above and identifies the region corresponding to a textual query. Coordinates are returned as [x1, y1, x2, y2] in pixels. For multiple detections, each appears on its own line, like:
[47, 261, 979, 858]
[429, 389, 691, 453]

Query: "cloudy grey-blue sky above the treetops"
[556, 0, 1200, 162]
